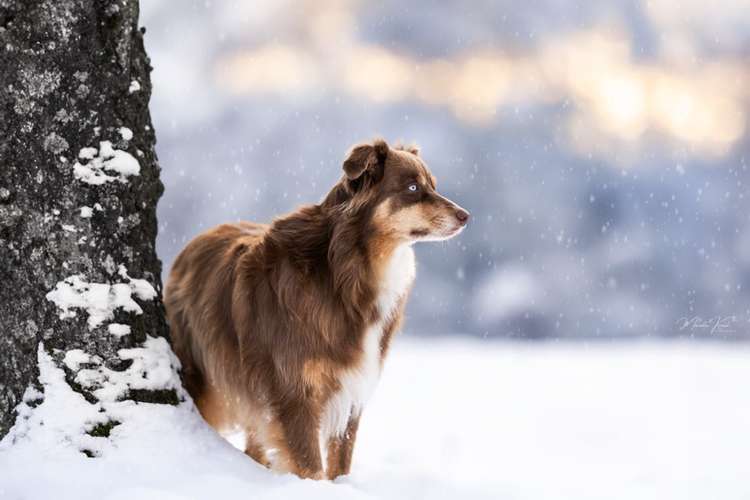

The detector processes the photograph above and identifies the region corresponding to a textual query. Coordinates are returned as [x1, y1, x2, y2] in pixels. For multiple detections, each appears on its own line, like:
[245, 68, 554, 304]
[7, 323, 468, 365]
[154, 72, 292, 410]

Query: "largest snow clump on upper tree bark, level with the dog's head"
[73, 140, 141, 186]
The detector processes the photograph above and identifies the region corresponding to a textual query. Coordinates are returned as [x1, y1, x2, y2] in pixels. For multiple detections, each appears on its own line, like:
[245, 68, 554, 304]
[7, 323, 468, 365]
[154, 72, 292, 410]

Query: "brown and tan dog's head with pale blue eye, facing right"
[329, 140, 469, 242]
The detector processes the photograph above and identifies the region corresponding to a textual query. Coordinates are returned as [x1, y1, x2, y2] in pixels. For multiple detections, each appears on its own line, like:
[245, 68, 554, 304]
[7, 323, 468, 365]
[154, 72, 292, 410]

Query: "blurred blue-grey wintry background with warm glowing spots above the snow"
[141, 0, 750, 339]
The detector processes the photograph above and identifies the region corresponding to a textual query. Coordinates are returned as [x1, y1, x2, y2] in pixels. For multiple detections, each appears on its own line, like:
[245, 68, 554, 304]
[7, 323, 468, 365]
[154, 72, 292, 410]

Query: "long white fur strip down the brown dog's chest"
[320, 245, 416, 448]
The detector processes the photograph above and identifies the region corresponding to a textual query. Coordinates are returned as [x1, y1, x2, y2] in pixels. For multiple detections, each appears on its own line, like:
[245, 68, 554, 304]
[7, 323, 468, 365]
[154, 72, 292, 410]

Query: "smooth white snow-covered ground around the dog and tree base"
[0, 338, 750, 500]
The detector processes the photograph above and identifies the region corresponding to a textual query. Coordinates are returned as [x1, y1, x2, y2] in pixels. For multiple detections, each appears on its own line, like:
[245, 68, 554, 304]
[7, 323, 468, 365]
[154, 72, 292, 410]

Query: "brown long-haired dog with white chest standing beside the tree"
[165, 140, 469, 479]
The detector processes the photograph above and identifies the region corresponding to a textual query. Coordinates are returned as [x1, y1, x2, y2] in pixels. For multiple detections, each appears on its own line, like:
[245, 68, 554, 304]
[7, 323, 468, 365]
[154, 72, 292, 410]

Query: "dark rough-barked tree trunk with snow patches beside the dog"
[0, 0, 178, 440]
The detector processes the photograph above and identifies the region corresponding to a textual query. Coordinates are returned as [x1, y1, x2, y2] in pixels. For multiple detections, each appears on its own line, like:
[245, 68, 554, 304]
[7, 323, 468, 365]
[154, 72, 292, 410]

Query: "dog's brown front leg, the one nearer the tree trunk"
[279, 400, 324, 479]
